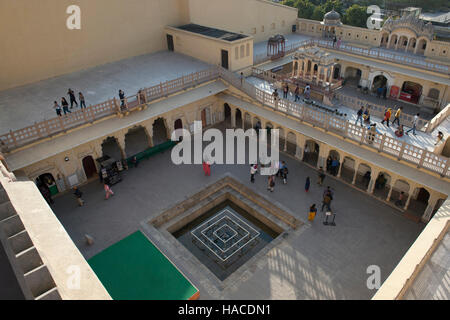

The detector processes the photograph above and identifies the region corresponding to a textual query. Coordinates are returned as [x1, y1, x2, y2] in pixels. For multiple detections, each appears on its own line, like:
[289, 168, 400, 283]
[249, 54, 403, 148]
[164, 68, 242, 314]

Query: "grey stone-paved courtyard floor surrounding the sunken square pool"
[52, 131, 424, 299]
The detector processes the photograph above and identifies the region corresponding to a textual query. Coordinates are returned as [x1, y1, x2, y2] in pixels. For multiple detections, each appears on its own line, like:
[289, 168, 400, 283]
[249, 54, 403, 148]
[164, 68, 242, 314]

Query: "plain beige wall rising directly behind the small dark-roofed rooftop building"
[188, 0, 297, 42]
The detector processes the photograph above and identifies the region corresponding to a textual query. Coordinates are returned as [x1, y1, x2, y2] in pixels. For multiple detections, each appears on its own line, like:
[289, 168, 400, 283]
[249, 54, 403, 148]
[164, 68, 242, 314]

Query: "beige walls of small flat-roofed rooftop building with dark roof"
[165, 27, 253, 71]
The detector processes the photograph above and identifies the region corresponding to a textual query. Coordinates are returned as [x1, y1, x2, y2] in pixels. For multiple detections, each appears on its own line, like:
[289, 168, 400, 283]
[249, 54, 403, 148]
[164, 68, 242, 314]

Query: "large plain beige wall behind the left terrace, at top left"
[0, 0, 188, 90]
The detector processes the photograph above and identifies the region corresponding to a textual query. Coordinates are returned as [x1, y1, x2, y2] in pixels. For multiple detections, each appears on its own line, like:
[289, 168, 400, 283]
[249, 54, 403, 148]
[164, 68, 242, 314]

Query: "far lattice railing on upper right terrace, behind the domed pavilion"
[253, 39, 450, 74]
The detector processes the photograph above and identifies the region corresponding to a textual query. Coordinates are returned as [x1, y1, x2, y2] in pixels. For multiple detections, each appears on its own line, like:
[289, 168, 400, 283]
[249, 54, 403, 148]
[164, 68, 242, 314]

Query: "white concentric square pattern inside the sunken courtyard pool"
[191, 209, 260, 261]
